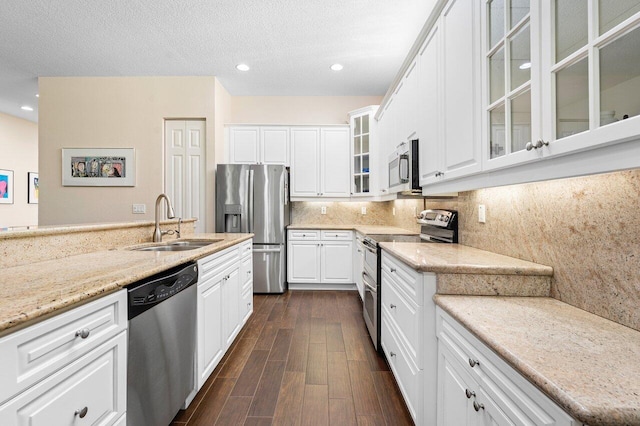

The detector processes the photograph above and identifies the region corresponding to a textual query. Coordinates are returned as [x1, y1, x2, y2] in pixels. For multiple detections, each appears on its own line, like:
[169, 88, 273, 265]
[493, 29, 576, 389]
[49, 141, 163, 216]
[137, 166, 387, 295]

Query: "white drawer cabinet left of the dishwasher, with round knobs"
[0, 290, 128, 425]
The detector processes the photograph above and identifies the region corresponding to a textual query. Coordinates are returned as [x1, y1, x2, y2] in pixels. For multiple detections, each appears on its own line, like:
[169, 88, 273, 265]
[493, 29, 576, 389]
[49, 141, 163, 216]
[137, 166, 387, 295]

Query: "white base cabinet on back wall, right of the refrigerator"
[287, 230, 354, 289]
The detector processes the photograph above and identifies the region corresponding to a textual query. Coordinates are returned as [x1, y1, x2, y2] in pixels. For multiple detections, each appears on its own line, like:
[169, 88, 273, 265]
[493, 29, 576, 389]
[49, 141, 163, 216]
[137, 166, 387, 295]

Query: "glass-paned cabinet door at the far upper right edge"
[548, 0, 640, 140]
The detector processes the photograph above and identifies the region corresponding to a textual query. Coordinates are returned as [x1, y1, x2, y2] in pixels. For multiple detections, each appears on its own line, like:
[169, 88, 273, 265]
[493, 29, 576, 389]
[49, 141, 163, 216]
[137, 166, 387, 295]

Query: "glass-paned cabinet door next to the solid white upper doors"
[484, 0, 537, 160]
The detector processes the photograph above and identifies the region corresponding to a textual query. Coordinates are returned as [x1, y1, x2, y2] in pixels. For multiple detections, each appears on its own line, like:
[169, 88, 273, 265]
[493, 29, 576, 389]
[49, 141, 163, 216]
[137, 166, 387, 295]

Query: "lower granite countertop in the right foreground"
[434, 295, 640, 426]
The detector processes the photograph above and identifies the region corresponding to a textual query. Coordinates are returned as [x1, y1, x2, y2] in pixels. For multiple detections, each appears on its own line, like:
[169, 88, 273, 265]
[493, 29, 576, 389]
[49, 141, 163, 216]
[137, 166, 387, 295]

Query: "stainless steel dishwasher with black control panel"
[127, 263, 198, 426]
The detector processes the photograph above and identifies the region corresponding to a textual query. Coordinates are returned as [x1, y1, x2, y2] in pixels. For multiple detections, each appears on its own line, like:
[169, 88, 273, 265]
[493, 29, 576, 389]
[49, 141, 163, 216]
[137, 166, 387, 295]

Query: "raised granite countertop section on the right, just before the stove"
[380, 242, 553, 276]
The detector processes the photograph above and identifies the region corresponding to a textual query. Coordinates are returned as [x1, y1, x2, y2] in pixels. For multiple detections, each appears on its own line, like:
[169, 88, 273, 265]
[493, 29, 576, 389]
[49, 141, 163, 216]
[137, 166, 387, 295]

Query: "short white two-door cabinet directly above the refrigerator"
[227, 126, 289, 166]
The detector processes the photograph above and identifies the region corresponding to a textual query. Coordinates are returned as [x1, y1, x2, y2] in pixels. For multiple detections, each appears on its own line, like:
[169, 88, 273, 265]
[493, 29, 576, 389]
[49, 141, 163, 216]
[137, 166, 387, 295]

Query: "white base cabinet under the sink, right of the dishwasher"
[196, 240, 253, 389]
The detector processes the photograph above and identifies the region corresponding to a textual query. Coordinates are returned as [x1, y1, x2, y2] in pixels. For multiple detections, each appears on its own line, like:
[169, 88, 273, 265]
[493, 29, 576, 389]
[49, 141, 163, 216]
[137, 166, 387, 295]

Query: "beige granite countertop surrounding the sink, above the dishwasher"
[0, 234, 253, 334]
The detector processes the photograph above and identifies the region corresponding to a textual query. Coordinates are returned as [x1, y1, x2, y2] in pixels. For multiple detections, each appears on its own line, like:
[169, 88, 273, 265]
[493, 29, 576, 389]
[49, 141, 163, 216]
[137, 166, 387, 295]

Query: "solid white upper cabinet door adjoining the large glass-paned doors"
[440, 0, 480, 179]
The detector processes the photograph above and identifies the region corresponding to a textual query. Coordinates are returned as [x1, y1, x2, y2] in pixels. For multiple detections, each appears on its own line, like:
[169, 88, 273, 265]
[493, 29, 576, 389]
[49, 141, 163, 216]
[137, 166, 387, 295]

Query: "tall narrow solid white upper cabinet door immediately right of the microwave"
[418, 26, 442, 185]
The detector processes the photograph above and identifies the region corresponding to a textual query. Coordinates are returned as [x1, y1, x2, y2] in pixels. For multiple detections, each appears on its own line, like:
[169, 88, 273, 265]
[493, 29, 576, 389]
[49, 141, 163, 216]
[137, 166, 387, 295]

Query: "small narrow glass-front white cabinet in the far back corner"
[349, 106, 378, 196]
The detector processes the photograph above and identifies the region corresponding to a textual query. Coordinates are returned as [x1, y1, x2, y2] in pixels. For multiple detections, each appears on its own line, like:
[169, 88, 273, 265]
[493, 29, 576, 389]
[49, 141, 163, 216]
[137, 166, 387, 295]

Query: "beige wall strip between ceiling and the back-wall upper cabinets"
[226, 96, 382, 125]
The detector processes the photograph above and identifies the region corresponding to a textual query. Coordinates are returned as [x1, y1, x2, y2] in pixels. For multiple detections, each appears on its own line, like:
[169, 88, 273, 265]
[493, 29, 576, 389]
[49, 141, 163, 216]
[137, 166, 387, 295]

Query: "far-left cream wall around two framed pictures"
[0, 113, 38, 228]
